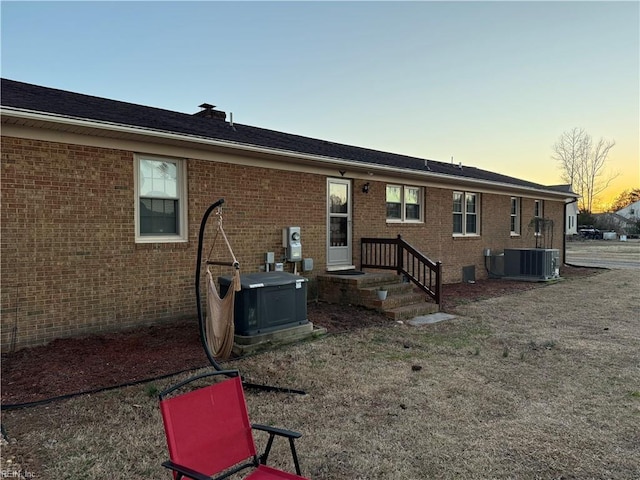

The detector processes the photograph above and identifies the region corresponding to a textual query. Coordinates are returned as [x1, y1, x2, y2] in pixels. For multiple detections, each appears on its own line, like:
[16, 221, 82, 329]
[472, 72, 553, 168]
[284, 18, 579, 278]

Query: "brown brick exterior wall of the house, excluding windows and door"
[0, 137, 563, 351]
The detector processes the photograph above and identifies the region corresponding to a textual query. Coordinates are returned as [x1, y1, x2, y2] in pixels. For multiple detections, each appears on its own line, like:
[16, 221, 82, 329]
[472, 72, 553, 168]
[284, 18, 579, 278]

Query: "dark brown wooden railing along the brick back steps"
[360, 235, 442, 305]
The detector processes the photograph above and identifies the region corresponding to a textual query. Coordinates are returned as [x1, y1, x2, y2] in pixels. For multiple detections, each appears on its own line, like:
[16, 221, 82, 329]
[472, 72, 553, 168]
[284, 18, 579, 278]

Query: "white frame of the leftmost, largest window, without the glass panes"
[133, 154, 189, 243]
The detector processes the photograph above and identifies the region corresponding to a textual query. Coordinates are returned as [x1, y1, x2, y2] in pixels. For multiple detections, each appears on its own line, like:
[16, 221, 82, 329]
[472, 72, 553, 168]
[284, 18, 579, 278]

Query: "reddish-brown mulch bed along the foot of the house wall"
[1, 267, 601, 408]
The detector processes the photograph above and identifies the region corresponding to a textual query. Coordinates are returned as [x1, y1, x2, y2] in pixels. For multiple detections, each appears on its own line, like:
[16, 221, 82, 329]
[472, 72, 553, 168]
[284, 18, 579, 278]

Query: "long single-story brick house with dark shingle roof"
[1, 79, 568, 349]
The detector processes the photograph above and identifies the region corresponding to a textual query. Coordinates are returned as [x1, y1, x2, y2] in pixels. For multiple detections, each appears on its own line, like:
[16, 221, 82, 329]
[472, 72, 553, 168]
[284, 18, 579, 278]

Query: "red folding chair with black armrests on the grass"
[159, 370, 308, 480]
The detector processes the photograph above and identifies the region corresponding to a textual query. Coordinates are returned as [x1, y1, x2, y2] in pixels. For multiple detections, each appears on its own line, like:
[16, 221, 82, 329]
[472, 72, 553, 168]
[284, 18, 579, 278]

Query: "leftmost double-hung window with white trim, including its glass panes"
[135, 155, 187, 243]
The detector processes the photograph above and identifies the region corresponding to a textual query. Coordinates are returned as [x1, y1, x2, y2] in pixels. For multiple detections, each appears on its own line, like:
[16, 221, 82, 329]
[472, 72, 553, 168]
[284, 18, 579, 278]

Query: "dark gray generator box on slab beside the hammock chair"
[218, 272, 309, 336]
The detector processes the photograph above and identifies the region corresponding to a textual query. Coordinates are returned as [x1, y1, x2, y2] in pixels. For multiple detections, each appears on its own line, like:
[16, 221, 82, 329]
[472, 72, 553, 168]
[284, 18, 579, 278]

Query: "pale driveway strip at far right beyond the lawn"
[567, 240, 640, 269]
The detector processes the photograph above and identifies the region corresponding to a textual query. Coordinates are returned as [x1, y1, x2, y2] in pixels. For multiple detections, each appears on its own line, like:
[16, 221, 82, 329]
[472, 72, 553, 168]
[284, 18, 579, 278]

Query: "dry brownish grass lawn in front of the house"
[2, 270, 640, 480]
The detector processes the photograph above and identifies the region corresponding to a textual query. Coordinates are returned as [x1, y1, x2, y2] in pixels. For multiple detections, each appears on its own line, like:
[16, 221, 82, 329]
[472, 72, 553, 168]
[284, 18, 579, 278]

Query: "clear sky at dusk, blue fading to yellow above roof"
[1, 1, 640, 208]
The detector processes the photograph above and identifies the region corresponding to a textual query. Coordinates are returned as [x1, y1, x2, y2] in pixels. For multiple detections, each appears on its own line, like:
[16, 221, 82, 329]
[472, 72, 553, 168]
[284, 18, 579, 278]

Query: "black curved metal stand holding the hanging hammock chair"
[195, 198, 306, 395]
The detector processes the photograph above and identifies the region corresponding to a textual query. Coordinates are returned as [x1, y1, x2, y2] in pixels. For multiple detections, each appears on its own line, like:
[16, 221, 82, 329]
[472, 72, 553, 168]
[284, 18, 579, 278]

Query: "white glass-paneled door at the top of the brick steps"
[327, 178, 353, 270]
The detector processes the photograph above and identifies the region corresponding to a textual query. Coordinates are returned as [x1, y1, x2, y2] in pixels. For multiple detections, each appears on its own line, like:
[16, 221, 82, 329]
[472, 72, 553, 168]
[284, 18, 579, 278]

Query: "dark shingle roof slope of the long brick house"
[0, 79, 564, 191]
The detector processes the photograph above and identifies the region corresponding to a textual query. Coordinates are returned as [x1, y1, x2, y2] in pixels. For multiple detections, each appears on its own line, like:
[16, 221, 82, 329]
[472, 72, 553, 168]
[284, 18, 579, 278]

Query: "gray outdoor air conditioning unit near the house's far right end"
[504, 248, 560, 280]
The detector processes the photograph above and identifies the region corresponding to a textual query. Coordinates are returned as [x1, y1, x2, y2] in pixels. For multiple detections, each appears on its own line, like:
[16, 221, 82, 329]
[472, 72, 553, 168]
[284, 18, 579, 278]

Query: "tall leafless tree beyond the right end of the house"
[552, 127, 617, 212]
